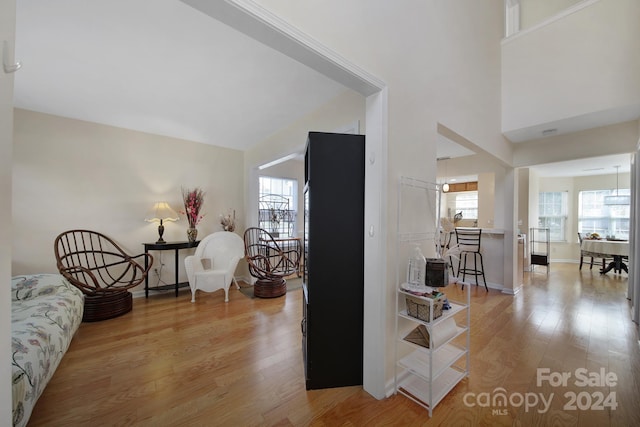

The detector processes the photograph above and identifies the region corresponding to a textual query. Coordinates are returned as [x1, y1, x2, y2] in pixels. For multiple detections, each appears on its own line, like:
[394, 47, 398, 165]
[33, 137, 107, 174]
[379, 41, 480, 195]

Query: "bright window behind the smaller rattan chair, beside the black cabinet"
[258, 176, 298, 237]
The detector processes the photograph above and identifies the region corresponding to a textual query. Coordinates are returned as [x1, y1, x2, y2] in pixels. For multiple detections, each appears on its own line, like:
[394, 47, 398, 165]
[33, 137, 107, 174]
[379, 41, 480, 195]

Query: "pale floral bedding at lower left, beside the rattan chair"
[11, 274, 84, 426]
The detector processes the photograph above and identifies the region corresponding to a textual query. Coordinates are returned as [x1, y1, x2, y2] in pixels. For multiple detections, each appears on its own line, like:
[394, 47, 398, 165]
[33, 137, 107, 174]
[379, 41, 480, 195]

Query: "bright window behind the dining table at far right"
[578, 188, 631, 240]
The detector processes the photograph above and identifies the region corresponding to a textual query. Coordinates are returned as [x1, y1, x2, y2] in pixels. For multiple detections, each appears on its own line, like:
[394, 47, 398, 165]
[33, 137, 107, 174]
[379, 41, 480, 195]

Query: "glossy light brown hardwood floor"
[29, 264, 640, 426]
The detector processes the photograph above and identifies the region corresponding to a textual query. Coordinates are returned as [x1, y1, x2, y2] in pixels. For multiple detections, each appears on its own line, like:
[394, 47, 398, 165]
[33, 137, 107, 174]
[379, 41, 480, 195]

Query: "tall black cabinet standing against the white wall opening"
[302, 132, 365, 389]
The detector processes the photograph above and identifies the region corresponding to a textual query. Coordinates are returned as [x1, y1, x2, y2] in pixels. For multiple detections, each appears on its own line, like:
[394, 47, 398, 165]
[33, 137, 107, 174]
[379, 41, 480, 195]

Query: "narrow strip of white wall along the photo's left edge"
[0, 0, 16, 418]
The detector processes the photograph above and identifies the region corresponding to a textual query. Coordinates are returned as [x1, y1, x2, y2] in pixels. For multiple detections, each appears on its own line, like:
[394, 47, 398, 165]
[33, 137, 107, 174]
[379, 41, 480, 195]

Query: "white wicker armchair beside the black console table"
[184, 231, 244, 302]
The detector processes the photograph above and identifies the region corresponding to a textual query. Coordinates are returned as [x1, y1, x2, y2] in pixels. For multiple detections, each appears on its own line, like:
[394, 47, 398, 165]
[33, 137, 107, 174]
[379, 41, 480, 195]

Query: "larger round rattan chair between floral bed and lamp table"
[54, 230, 153, 322]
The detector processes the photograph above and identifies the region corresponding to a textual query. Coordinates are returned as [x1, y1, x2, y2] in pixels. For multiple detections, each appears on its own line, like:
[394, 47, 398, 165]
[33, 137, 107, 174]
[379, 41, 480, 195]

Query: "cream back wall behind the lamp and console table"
[10, 109, 244, 285]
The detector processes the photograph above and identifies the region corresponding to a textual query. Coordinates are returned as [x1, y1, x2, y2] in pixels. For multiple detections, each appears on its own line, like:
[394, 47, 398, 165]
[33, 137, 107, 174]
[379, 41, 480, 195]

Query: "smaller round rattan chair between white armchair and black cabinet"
[244, 227, 301, 298]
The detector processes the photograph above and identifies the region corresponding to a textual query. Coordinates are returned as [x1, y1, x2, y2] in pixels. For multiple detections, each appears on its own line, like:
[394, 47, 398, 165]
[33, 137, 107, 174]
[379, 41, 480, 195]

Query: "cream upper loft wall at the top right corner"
[502, 0, 640, 132]
